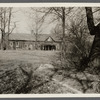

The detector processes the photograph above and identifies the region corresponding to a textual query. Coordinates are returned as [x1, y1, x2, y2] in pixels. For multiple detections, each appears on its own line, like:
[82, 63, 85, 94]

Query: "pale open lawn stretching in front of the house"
[0, 50, 56, 66]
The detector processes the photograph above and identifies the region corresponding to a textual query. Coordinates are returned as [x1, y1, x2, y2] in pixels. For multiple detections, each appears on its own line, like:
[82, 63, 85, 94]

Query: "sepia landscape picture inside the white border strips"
[0, 3, 100, 95]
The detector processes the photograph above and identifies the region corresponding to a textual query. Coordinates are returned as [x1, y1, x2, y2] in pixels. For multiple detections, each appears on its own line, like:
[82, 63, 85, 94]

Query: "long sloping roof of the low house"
[9, 33, 59, 41]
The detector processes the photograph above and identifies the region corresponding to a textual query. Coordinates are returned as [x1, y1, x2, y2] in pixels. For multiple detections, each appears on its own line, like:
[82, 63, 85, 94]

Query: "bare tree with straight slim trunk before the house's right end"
[39, 7, 73, 63]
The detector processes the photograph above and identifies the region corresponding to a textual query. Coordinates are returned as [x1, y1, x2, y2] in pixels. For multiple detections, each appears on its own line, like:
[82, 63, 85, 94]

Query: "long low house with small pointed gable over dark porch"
[9, 34, 61, 50]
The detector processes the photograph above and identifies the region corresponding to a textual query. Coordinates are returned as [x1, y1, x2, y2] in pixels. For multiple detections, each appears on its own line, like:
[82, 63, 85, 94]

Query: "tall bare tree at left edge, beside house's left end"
[0, 7, 16, 50]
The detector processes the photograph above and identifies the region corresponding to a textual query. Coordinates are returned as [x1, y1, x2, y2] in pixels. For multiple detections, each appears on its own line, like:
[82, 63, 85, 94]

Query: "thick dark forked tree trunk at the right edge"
[85, 7, 100, 67]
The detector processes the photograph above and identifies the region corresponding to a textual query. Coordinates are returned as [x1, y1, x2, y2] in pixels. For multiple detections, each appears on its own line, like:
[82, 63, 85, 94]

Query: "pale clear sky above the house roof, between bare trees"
[13, 7, 56, 34]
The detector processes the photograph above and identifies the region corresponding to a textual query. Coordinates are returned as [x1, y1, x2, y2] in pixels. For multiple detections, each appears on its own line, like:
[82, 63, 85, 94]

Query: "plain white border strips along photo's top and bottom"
[0, 2, 100, 97]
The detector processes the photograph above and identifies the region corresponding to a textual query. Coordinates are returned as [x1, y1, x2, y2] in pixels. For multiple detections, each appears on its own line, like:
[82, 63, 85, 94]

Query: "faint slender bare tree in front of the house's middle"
[29, 8, 44, 50]
